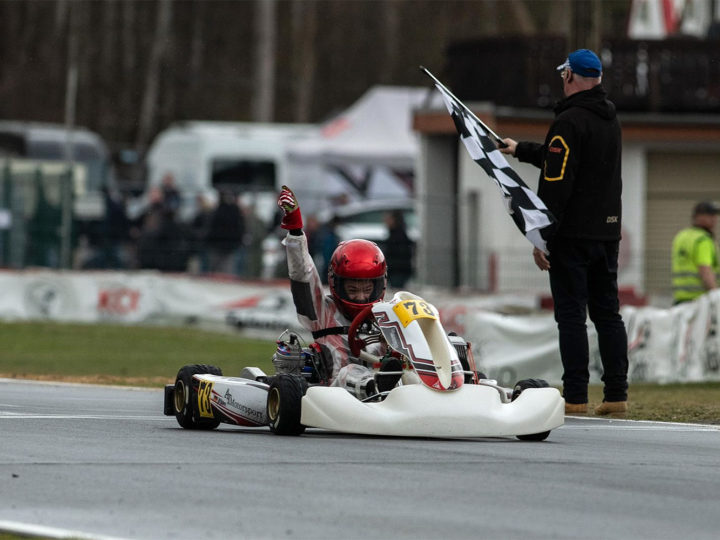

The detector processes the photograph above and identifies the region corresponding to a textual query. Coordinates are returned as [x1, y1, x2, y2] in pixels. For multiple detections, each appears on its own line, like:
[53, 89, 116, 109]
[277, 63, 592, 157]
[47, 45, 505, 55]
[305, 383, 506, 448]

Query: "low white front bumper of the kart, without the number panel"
[300, 384, 565, 438]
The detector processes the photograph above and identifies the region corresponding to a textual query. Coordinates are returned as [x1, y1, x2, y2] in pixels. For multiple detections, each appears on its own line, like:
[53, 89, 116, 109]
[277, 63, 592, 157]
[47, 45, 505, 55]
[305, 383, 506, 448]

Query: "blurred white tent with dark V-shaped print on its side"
[288, 86, 429, 211]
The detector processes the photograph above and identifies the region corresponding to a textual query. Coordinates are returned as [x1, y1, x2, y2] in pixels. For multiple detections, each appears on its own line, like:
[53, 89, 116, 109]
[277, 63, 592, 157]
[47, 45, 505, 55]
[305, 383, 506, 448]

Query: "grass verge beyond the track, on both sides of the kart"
[0, 323, 720, 424]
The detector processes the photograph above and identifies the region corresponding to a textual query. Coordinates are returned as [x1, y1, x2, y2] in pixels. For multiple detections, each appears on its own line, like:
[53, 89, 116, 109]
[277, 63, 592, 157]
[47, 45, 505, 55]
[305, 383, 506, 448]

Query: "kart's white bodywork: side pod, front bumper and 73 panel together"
[177, 291, 565, 440]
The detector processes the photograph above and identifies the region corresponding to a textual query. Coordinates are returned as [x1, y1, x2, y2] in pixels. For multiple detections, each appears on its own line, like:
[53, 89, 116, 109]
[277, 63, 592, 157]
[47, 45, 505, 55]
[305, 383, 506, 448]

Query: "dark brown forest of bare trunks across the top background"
[0, 0, 630, 155]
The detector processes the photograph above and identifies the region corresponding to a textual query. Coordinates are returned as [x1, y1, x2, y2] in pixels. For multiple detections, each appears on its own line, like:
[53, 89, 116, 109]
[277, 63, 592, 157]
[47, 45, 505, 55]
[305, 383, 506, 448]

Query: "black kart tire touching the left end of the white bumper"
[267, 373, 308, 435]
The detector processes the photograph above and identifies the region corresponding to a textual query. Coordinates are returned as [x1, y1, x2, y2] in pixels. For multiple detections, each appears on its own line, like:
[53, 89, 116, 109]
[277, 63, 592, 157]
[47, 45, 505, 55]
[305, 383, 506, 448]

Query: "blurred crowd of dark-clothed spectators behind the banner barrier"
[26, 174, 414, 289]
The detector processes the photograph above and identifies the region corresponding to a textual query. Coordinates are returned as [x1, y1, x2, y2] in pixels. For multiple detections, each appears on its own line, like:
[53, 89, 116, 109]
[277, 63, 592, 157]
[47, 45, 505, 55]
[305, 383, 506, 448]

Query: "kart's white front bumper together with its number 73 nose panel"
[301, 292, 565, 437]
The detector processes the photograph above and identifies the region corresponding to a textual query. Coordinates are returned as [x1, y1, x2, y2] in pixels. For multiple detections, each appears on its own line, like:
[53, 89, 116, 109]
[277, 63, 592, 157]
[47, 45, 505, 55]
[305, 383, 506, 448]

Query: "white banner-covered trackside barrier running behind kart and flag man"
[0, 270, 720, 386]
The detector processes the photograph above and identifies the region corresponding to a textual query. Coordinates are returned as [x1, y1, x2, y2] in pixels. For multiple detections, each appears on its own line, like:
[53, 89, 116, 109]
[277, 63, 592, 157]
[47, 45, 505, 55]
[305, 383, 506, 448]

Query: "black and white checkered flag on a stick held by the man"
[423, 68, 555, 253]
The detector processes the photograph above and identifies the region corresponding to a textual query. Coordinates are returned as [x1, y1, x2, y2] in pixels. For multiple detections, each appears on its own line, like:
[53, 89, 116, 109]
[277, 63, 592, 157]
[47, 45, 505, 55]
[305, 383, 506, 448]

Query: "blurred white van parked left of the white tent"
[145, 121, 318, 222]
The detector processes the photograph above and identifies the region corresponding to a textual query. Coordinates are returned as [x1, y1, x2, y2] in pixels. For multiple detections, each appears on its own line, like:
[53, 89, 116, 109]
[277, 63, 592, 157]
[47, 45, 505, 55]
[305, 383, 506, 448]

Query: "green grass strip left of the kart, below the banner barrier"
[0, 323, 275, 386]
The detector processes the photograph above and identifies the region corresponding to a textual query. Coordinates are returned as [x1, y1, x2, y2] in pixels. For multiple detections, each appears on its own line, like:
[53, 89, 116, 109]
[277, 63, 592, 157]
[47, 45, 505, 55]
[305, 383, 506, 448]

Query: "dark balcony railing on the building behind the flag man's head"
[445, 36, 720, 113]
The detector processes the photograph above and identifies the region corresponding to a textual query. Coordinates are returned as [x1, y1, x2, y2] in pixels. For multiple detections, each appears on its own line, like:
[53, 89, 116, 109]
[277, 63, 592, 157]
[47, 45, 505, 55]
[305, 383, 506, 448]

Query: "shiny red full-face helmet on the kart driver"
[328, 240, 387, 320]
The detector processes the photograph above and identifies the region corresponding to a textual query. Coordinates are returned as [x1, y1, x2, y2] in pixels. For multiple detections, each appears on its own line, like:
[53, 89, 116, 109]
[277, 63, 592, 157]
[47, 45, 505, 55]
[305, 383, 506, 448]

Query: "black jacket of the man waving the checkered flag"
[515, 85, 622, 240]
